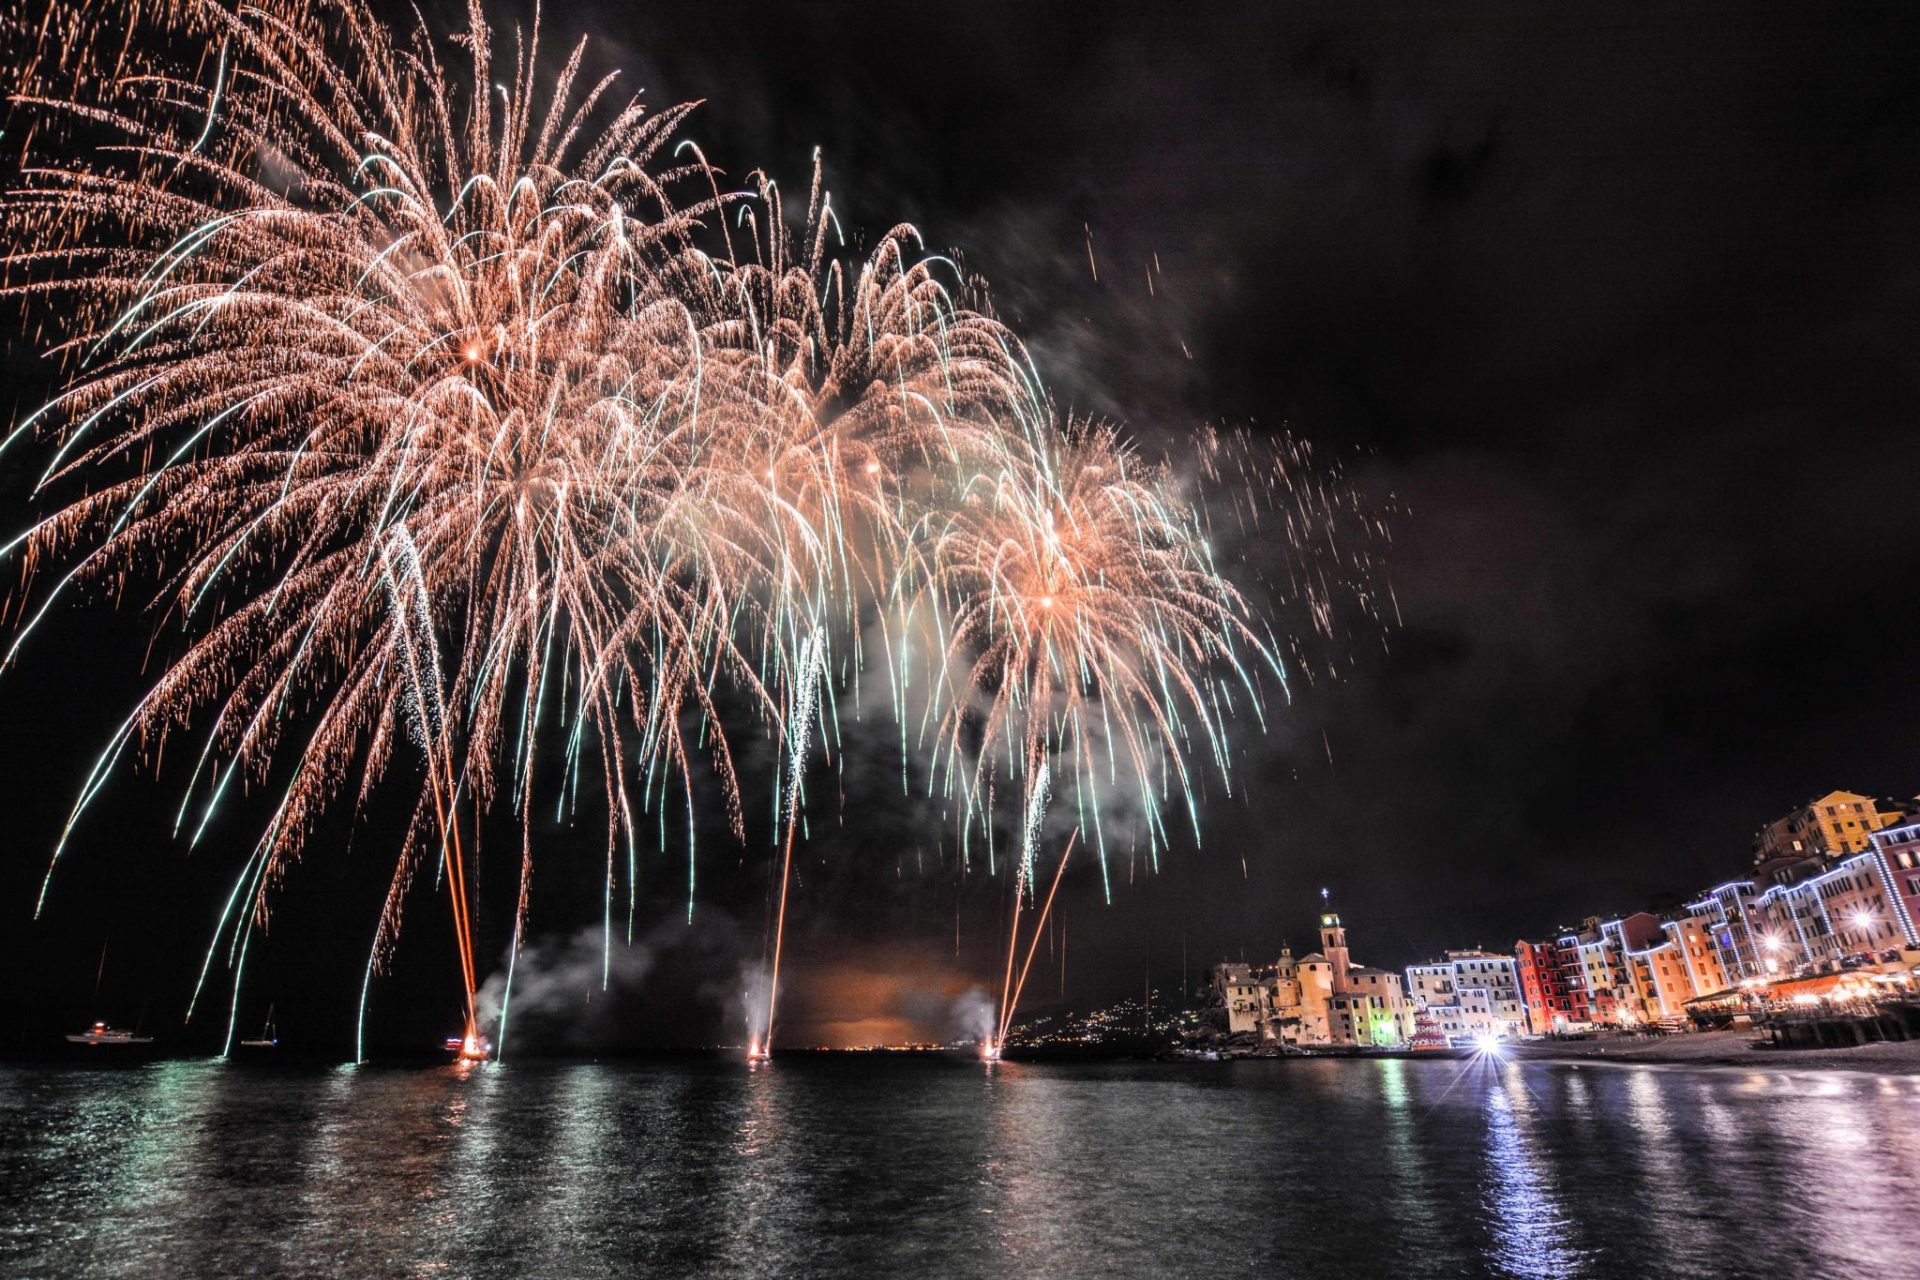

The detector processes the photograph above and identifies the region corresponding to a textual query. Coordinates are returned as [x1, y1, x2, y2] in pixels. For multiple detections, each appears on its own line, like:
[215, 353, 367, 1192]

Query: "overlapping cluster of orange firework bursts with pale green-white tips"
[0, 0, 1382, 1046]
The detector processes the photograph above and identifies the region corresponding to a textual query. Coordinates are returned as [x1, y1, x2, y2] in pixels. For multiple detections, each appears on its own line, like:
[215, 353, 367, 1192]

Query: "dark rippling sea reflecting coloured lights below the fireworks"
[0, 1057, 1920, 1278]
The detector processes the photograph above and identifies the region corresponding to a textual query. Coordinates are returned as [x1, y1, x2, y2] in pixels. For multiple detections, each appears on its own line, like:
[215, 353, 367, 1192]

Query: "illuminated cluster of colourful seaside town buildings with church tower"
[1213, 791, 1920, 1048]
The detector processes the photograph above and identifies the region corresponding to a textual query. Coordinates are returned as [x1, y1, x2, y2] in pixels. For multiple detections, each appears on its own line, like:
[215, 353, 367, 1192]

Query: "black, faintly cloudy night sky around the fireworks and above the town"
[0, 2, 1920, 1046]
